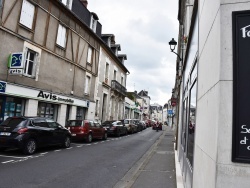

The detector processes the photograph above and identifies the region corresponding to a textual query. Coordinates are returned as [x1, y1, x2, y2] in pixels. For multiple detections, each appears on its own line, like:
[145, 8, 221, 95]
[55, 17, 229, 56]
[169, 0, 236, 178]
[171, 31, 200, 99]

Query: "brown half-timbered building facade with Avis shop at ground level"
[0, 0, 102, 125]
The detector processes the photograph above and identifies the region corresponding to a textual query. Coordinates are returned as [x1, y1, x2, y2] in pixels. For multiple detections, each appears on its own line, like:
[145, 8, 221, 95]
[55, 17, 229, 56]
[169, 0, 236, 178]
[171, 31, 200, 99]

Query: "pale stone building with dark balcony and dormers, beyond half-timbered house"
[95, 34, 129, 122]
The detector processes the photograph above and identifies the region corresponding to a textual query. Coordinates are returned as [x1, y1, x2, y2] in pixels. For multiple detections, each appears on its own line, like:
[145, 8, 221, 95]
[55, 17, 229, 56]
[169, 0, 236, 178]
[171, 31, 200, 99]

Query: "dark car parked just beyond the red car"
[102, 120, 128, 137]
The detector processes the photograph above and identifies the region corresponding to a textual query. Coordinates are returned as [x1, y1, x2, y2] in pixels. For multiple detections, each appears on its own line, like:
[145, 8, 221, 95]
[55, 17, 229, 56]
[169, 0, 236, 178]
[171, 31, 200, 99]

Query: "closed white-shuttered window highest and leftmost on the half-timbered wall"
[19, 0, 35, 29]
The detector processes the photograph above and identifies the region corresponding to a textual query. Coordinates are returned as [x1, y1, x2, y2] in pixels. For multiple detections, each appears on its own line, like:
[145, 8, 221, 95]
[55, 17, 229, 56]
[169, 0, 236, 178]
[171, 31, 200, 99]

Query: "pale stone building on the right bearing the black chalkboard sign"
[172, 0, 250, 188]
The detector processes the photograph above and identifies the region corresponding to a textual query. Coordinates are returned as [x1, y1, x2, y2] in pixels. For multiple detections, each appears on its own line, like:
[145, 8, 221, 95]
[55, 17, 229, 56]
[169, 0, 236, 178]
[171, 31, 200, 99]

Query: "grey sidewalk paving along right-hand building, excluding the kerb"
[132, 126, 176, 188]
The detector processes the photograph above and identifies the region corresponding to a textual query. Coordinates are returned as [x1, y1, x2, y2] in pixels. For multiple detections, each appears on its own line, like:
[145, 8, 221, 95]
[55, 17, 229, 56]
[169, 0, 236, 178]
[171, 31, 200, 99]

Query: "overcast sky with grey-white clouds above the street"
[88, 0, 178, 105]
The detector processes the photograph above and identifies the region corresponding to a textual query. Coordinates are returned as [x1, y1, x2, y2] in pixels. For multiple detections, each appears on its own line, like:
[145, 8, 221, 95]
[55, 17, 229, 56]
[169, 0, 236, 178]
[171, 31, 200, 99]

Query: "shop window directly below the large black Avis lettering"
[37, 102, 58, 121]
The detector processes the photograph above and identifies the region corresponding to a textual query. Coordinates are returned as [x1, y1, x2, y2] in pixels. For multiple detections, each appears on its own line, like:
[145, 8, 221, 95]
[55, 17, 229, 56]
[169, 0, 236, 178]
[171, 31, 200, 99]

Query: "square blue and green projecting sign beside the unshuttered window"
[8, 52, 24, 75]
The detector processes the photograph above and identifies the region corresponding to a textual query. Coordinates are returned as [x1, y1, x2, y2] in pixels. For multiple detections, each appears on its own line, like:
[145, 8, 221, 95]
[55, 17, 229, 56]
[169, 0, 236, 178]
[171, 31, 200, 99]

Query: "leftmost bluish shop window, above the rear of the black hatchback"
[4, 97, 25, 119]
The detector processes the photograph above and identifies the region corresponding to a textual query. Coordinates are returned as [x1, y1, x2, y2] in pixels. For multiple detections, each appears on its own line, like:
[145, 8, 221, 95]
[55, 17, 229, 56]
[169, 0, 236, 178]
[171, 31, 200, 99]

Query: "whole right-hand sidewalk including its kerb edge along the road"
[115, 126, 183, 188]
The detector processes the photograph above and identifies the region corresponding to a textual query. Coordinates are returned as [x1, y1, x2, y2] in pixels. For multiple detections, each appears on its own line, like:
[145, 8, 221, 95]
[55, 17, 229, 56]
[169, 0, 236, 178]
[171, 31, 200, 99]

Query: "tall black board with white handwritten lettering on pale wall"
[232, 11, 250, 163]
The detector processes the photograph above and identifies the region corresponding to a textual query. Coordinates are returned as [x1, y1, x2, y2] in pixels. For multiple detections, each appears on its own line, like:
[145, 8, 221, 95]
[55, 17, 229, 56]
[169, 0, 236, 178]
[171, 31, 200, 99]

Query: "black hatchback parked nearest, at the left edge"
[0, 117, 71, 155]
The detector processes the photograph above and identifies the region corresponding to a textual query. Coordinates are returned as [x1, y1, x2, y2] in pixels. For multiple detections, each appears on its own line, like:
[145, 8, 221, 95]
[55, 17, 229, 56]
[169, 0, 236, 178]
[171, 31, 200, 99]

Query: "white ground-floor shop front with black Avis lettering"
[0, 81, 89, 125]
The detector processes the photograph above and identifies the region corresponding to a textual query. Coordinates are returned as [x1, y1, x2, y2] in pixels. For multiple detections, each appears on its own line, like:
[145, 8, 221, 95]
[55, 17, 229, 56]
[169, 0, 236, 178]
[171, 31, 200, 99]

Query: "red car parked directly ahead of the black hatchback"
[66, 120, 107, 142]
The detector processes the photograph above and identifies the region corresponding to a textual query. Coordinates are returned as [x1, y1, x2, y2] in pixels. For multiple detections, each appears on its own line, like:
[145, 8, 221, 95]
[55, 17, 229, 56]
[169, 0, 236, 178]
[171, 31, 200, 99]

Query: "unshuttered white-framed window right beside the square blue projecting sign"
[23, 48, 39, 77]
